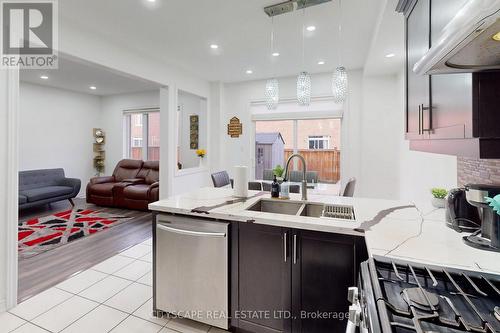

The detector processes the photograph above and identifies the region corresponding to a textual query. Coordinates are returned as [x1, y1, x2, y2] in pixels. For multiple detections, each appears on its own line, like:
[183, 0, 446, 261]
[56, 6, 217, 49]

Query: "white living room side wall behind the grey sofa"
[19, 82, 100, 195]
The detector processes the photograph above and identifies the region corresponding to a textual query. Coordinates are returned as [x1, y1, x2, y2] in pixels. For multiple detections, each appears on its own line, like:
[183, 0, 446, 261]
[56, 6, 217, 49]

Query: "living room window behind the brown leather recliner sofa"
[124, 110, 160, 161]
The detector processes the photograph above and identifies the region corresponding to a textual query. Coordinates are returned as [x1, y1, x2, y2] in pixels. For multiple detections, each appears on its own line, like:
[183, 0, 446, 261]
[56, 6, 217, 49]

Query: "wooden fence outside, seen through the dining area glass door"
[285, 149, 340, 183]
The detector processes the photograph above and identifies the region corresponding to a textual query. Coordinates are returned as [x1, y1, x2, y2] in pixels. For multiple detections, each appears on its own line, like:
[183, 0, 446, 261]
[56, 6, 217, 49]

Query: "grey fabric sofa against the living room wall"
[19, 169, 81, 209]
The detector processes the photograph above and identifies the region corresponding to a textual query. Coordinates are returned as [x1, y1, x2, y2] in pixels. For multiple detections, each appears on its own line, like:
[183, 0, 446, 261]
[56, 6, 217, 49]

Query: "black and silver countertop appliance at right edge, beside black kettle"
[464, 184, 500, 252]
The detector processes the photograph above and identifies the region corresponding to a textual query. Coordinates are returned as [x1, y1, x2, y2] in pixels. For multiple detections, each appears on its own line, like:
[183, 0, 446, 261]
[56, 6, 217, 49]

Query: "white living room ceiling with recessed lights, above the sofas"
[20, 56, 160, 96]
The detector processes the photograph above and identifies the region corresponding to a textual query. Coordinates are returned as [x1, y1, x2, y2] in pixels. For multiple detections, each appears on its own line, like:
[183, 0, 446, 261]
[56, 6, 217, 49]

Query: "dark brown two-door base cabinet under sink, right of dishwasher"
[231, 219, 367, 333]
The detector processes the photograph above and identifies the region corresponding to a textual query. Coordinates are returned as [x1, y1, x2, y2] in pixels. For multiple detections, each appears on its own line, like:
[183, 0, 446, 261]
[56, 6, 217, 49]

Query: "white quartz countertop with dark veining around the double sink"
[149, 188, 500, 274]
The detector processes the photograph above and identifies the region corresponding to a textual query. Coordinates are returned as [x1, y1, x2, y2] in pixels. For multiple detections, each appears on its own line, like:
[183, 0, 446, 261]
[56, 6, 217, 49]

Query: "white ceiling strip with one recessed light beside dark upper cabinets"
[365, 0, 405, 75]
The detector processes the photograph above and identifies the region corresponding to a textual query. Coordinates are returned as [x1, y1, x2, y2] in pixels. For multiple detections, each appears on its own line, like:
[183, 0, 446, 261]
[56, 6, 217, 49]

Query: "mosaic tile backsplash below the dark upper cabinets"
[457, 157, 500, 186]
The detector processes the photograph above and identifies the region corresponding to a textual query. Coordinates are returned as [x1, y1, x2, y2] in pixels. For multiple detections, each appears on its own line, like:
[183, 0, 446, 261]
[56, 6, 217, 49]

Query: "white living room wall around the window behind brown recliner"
[101, 90, 162, 171]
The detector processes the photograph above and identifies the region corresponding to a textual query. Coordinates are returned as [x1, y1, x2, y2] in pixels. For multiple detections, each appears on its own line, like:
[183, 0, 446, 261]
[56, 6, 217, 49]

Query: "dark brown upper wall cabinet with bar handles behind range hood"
[398, 0, 500, 158]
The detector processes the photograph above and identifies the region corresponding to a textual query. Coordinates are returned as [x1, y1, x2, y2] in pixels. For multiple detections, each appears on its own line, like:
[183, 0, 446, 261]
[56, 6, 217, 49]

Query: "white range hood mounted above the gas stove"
[413, 0, 500, 75]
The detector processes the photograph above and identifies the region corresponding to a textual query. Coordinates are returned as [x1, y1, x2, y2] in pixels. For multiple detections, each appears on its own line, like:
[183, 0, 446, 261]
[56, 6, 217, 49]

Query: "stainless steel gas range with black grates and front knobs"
[348, 257, 500, 333]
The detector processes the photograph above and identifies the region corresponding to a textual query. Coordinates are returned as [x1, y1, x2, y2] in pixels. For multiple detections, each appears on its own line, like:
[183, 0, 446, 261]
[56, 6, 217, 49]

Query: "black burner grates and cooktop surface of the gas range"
[374, 262, 500, 333]
